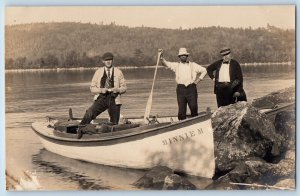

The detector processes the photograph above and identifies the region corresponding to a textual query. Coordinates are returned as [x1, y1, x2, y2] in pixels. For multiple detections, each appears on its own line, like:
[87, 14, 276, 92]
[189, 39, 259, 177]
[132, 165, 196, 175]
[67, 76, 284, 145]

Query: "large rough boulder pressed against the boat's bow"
[212, 102, 284, 174]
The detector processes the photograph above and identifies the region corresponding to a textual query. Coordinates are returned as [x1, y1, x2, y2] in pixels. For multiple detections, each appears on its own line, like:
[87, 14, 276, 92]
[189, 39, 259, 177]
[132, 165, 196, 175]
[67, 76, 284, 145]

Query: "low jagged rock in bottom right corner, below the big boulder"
[210, 155, 296, 190]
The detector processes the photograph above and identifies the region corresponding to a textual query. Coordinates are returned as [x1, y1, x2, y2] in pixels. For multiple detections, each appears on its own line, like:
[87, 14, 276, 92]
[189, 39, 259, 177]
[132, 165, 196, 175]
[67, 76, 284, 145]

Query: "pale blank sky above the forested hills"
[5, 5, 295, 29]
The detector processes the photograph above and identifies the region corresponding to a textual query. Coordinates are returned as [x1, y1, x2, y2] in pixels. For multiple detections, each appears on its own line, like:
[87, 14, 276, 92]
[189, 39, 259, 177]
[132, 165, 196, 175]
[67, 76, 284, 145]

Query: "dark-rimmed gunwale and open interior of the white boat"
[32, 114, 210, 141]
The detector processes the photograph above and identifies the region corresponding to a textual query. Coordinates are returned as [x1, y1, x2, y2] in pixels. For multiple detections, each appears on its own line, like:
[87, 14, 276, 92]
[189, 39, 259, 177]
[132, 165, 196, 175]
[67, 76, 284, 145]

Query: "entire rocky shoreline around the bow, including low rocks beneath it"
[134, 87, 296, 190]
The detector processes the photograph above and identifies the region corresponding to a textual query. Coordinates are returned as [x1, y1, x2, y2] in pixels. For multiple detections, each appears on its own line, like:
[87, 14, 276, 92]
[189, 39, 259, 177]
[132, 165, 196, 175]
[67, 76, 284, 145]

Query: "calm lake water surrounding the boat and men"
[5, 68, 295, 190]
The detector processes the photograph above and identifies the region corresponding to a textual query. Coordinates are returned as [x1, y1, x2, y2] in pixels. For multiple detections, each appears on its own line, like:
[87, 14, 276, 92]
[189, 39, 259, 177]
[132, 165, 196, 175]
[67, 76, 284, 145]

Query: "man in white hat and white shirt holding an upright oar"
[160, 48, 207, 120]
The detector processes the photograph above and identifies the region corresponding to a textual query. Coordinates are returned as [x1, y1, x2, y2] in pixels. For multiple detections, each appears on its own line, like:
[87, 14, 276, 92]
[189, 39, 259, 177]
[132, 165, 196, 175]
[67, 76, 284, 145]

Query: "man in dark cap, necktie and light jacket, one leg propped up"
[80, 52, 127, 125]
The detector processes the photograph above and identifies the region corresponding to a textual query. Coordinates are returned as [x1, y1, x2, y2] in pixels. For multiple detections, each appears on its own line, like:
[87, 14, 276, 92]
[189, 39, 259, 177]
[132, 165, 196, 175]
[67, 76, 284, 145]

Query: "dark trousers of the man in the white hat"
[176, 84, 198, 120]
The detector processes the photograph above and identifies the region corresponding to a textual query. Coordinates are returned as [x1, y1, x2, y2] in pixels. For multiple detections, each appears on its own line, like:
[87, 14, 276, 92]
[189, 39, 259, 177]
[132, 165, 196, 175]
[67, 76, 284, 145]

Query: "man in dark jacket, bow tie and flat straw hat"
[207, 47, 247, 107]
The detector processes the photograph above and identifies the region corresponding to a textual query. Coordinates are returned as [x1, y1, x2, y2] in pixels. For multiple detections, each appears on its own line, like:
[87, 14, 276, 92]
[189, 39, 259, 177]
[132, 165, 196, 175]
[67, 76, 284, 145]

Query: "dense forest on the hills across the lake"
[5, 22, 295, 69]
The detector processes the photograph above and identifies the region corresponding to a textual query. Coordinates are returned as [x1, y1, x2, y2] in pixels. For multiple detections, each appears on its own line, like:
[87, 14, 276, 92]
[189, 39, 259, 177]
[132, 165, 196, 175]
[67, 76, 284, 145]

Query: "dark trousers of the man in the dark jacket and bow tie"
[216, 82, 234, 107]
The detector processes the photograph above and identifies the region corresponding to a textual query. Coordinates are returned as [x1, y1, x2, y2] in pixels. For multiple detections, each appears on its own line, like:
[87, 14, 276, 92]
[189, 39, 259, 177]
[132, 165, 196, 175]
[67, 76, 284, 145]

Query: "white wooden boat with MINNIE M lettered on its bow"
[32, 113, 215, 178]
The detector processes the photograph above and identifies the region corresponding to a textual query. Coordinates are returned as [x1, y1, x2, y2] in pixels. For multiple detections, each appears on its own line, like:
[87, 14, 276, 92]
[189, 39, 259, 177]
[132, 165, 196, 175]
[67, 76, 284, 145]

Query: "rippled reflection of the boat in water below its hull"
[32, 149, 144, 190]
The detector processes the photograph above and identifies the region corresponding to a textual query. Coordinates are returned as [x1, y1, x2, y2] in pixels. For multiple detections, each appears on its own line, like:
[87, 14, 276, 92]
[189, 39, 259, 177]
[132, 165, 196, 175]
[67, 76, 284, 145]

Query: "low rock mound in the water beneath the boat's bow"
[133, 166, 196, 190]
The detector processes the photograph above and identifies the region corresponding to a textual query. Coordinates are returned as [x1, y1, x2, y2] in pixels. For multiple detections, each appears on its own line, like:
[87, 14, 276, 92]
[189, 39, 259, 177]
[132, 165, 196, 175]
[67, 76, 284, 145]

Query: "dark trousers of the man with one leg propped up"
[80, 93, 121, 125]
